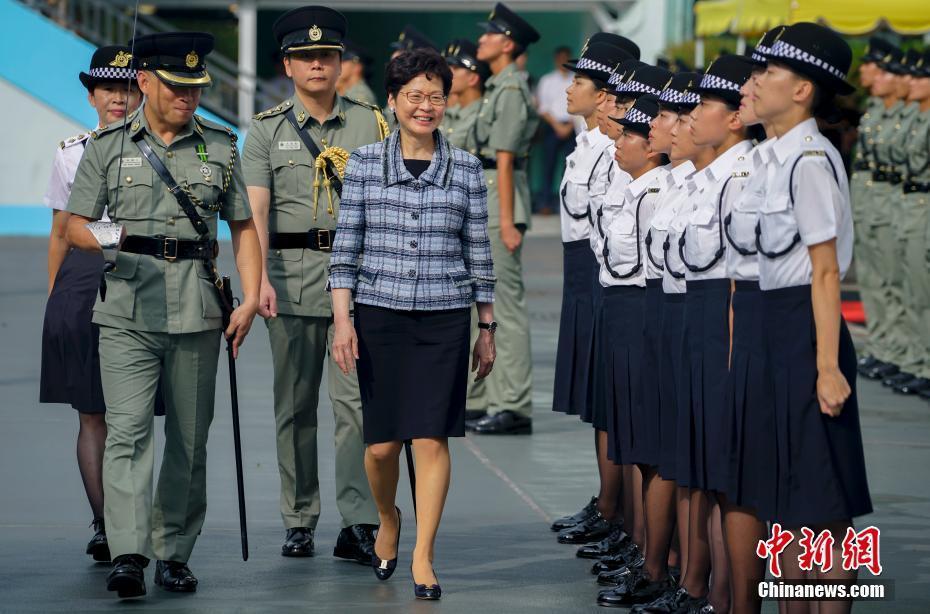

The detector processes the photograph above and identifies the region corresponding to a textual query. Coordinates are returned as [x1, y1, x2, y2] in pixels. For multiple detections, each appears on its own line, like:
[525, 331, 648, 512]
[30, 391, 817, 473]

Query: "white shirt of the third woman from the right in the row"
[672, 141, 752, 281]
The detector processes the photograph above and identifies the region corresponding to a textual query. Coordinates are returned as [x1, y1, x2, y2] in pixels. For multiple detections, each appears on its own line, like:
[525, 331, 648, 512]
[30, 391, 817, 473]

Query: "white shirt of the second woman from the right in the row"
[723, 137, 775, 281]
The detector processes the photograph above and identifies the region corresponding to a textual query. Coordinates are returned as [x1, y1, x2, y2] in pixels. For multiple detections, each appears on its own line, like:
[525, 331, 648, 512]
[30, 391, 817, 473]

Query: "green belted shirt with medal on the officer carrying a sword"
[68, 107, 252, 334]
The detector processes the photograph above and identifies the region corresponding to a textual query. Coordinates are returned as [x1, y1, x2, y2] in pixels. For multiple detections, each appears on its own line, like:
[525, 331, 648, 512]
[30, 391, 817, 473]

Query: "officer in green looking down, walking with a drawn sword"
[68, 32, 261, 597]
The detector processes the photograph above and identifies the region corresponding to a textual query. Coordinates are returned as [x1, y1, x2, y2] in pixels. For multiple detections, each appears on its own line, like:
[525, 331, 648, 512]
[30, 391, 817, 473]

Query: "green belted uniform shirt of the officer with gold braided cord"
[242, 94, 386, 317]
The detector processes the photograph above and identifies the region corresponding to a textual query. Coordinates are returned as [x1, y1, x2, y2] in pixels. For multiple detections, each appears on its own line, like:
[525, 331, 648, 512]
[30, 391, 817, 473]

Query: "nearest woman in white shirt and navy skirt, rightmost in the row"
[754, 22, 872, 613]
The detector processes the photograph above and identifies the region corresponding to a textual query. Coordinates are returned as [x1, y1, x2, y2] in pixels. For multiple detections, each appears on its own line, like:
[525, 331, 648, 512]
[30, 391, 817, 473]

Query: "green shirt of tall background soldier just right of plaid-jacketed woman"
[474, 64, 539, 228]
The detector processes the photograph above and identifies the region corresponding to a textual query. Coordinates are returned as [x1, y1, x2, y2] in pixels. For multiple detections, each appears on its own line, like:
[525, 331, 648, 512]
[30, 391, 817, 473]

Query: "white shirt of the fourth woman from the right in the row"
[646, 160, 695, 293]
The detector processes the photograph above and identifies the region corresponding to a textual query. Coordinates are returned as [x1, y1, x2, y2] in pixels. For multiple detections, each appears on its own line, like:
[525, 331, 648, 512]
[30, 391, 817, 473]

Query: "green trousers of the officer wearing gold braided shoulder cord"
[265, 314, 378, 529]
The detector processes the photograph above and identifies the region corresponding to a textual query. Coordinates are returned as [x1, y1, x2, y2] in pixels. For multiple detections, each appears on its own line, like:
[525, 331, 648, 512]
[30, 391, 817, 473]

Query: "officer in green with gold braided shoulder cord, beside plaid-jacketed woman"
[243, 6, 386, 564]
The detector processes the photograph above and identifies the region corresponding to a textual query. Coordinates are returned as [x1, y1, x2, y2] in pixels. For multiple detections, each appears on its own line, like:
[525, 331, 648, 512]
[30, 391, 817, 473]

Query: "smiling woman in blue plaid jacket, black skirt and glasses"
[330, 49, 496, 599]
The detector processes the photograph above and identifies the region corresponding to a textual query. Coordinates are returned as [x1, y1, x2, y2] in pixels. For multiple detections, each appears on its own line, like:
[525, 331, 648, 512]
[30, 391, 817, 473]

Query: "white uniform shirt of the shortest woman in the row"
[600, 166, 668, 287]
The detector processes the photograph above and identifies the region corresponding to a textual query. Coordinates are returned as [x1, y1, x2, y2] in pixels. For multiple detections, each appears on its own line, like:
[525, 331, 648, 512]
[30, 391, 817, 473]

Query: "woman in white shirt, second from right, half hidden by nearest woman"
[718, 26, 785, 612]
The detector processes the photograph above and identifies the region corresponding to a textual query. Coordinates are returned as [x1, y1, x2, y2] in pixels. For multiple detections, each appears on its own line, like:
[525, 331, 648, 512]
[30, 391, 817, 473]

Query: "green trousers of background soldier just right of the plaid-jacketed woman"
[466, 226, 533, 416]
